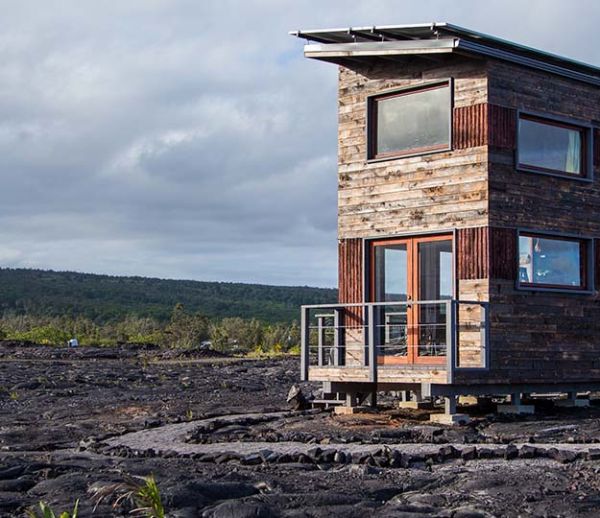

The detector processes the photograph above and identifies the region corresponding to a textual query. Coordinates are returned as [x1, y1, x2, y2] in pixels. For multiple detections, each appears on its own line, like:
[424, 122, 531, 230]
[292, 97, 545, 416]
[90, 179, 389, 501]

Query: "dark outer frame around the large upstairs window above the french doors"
[365, 77, 454, 163]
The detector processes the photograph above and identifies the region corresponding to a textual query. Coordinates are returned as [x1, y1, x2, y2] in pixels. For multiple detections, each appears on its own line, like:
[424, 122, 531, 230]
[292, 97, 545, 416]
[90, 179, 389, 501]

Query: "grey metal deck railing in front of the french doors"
[301, 299, 490, 383]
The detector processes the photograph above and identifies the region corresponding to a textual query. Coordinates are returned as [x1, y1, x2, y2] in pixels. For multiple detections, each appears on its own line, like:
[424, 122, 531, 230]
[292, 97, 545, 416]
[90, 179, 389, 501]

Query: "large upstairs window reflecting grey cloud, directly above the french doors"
[368, 81, 452, 159]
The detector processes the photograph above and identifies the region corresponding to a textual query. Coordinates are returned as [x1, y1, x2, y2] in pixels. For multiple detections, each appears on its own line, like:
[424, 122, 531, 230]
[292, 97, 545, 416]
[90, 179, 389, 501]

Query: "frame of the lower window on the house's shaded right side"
[515, 229, 596, 294]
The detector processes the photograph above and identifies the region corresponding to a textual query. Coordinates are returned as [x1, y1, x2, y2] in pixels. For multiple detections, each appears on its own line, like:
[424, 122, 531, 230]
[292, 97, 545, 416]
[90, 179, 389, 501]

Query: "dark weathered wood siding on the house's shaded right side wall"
[480, 61, 600, 383]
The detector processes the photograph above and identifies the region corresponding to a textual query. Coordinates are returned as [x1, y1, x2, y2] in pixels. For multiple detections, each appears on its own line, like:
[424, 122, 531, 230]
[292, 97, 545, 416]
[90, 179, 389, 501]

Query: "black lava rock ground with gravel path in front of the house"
[0, 344, 600, 518]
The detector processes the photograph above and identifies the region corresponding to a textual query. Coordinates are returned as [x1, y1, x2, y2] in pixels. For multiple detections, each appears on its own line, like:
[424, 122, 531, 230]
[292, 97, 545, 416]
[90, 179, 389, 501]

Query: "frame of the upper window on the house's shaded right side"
[515, 110, 594, 182]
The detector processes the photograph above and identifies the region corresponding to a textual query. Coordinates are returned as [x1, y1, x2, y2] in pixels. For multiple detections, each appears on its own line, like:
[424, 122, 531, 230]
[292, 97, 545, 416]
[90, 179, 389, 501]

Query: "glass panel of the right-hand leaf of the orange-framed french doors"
[416, 239, 452, 356]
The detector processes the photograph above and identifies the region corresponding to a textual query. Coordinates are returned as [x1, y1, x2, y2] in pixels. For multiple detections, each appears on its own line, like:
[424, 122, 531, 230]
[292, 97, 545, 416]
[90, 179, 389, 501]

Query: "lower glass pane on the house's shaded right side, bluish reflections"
[519, 235, 583, 288]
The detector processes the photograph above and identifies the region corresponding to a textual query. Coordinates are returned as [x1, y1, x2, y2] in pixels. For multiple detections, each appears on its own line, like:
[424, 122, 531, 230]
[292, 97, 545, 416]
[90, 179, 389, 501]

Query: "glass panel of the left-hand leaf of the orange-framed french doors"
[375, 244, 408, 358]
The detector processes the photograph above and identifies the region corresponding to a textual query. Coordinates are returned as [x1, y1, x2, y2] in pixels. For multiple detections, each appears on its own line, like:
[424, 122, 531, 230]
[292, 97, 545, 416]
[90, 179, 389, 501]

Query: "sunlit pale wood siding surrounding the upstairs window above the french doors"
[338, 60, 488, 239]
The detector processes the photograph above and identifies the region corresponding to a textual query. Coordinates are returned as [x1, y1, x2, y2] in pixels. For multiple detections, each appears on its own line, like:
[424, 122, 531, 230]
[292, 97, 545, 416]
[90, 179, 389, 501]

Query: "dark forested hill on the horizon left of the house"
[0, 268, 337, 323]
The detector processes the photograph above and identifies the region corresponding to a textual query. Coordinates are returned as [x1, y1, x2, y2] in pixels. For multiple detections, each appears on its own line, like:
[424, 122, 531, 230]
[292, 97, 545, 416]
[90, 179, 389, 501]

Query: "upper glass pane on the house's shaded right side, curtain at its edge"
[519, 119, 582, 175]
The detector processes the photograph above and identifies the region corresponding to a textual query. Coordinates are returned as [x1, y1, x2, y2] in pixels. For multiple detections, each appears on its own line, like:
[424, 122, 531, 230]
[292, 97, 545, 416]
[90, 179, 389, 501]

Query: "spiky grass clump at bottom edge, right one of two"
[89, 475, 165, 518]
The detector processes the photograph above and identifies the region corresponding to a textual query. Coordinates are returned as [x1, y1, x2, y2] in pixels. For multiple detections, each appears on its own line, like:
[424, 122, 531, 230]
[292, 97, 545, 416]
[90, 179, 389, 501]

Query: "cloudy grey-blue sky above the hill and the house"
[0, 0, 600, 287]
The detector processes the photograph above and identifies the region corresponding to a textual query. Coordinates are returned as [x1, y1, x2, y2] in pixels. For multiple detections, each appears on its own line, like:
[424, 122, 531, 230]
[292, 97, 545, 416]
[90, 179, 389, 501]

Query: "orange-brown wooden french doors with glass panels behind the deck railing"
[370, 234, 453, 364]
